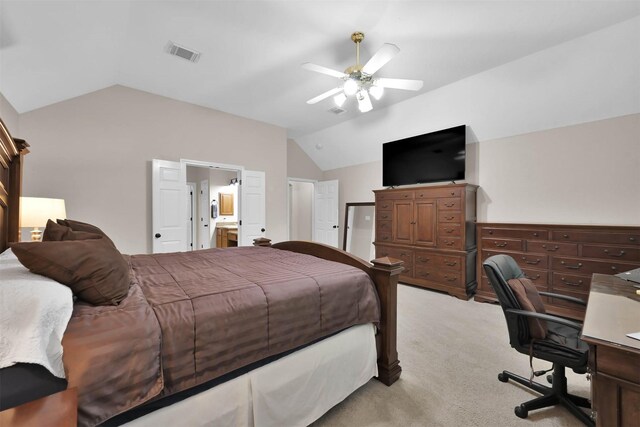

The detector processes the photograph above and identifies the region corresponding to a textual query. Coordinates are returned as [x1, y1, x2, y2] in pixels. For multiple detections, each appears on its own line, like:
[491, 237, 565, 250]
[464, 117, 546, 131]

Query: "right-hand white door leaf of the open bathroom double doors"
[238, 170, 267, 246]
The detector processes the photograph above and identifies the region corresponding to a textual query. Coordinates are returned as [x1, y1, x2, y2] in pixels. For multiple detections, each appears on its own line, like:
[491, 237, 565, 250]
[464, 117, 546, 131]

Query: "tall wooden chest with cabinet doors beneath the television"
[374, 184, 477, 299]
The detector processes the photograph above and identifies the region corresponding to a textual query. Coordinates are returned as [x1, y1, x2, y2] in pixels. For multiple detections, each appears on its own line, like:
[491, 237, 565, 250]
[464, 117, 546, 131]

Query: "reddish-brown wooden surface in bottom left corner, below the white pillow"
[0, 388, 78, 427]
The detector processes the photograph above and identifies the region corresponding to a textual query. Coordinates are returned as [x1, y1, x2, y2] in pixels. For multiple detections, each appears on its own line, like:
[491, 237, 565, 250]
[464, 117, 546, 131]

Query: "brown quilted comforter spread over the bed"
[65, 247, 380, 425]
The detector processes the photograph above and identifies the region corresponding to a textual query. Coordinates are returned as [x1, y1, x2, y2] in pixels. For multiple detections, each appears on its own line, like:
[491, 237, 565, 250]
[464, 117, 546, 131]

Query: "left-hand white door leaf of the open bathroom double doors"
[151, 159, 187, 253]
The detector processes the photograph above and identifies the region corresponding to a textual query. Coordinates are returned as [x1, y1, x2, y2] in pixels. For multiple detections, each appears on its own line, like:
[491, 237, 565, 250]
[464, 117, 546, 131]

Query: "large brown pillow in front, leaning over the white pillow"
[11, 238, 129, 305]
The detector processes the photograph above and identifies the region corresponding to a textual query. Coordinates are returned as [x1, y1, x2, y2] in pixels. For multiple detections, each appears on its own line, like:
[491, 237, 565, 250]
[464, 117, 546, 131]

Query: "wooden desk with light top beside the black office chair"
[581, 274, 640, 427]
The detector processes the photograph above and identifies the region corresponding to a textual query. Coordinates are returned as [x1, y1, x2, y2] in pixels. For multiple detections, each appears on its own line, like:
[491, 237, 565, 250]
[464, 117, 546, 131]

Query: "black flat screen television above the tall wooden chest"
[382, 125, 466, 187]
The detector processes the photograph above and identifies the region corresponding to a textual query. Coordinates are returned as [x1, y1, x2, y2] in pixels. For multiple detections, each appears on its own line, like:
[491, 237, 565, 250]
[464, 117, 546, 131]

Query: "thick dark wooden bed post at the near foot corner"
[371, 257, 404, 386]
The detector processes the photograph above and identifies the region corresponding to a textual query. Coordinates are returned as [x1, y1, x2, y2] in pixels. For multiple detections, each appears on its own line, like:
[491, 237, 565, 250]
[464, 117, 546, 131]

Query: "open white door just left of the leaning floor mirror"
[313, 179, 340, 248]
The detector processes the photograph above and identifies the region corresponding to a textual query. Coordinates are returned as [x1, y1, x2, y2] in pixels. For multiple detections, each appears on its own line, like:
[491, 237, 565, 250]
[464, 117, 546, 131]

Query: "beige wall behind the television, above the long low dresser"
[323, 114, 640, 230]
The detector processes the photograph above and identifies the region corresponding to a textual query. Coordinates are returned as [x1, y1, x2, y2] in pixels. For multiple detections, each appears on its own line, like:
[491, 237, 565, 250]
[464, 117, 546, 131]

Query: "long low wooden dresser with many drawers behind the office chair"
[475, 223, 640, 319]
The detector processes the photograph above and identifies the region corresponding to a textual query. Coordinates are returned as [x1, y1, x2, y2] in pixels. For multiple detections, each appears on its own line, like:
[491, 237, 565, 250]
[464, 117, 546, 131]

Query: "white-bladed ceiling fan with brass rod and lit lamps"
[302, 31, 422, 113]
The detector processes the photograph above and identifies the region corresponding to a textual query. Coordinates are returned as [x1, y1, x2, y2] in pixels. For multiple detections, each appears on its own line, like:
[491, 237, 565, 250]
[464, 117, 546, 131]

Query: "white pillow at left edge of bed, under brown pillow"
[0, 249, 73, 378]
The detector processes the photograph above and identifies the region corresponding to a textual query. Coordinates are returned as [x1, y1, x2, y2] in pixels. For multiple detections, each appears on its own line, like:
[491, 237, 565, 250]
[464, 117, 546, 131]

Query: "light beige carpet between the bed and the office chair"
[312, 285, 590, 427]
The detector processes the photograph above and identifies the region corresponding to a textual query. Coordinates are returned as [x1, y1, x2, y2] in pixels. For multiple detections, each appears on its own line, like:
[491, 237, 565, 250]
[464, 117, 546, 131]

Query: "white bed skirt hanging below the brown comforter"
[125, 324, 378, 427]
